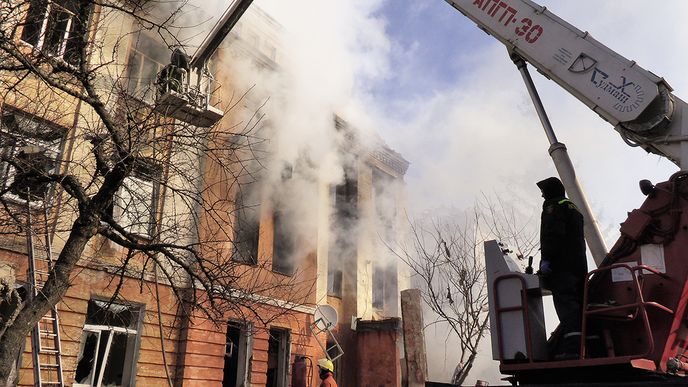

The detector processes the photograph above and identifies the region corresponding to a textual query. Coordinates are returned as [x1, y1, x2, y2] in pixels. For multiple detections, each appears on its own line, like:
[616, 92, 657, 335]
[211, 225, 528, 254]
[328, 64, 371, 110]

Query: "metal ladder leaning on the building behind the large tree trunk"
[26, 195, 64, 387]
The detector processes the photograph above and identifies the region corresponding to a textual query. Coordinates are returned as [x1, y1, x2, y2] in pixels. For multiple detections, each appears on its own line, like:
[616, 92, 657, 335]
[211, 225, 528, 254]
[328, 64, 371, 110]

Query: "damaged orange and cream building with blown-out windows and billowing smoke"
[0, 0, 409, 387]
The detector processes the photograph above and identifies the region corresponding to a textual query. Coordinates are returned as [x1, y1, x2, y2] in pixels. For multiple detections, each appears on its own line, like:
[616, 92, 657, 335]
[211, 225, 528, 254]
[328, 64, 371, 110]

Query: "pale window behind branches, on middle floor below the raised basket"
[113, 161, 162, 238]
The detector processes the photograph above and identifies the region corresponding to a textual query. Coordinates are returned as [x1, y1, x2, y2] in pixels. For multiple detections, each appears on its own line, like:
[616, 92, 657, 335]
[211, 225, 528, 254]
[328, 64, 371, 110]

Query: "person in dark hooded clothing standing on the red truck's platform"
[537, 177, 588, 360]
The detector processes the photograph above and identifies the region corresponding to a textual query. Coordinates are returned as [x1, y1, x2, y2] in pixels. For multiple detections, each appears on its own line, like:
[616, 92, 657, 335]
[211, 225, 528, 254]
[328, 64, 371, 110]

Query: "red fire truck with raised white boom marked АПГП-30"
[446, 0, 688, 386]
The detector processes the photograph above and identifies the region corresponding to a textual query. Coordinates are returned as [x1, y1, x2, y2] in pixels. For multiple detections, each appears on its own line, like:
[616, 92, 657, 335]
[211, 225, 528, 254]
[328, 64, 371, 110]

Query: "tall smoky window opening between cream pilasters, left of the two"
[327, 168, 358, 297]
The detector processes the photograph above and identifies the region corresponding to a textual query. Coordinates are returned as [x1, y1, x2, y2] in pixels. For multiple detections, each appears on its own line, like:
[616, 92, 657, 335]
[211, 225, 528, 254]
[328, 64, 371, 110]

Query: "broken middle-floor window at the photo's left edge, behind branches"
[0, 111, 67, 201]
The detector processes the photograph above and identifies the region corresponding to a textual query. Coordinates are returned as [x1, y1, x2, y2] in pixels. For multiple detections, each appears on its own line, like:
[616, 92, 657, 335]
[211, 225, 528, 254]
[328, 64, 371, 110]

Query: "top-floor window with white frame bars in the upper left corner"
[21, 0, 88, 65]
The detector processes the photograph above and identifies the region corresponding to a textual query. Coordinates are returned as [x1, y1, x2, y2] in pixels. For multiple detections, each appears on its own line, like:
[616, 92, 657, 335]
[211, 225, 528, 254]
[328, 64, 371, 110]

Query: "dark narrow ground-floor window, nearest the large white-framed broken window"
[222, 321, 252, 387]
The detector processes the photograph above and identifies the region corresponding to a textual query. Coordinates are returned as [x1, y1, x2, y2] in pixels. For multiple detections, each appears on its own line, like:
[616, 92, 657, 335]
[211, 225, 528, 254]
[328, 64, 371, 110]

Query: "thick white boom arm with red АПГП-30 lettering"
[446, 0, 688, 170]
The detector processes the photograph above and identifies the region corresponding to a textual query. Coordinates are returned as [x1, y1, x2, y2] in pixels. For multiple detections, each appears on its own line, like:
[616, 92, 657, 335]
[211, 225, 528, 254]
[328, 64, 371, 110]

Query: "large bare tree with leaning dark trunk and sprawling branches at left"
[0, 0, 313, 380]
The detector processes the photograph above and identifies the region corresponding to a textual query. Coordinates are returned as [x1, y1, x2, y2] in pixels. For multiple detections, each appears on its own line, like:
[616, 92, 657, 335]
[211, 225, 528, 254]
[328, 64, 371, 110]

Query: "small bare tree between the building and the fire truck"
[393, 199, 538, 385]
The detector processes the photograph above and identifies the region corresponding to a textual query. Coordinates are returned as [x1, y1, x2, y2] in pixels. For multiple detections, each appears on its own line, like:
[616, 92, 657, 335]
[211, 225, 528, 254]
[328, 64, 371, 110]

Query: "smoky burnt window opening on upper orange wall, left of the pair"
[232, 183, 260, 265]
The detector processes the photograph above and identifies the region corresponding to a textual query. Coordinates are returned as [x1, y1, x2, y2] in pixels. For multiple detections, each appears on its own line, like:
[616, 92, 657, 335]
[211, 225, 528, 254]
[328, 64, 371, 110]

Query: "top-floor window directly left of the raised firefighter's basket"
[126, 33, 170, 103]
